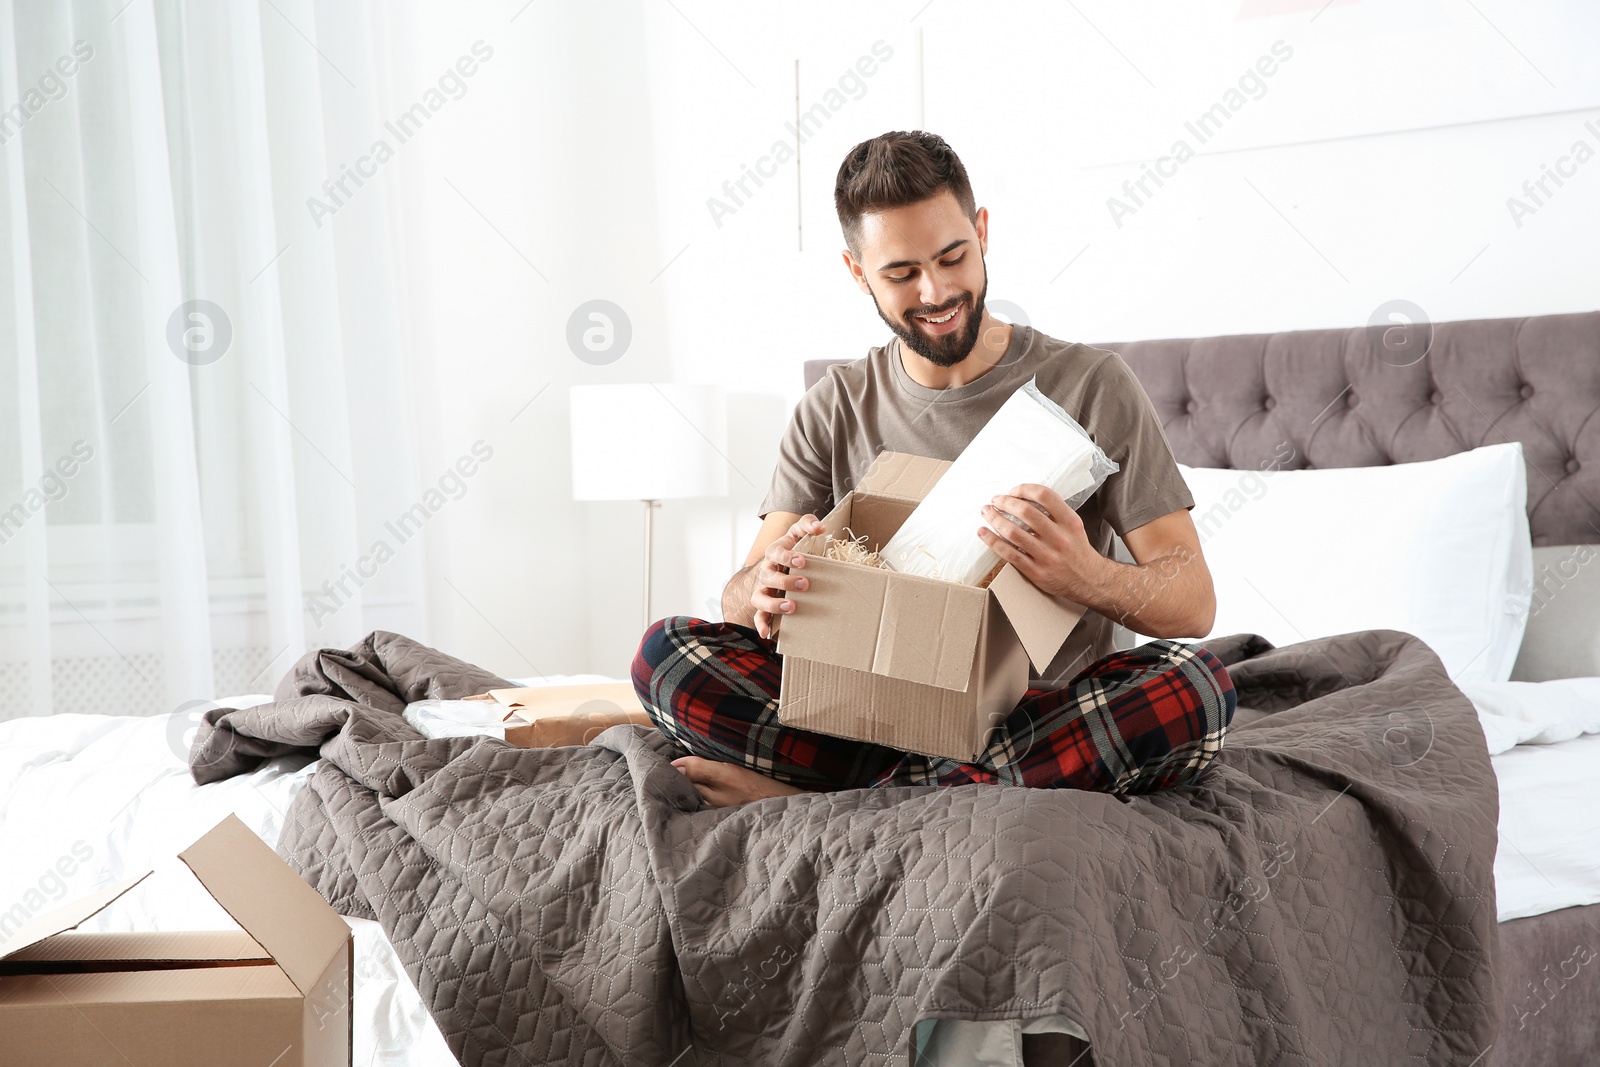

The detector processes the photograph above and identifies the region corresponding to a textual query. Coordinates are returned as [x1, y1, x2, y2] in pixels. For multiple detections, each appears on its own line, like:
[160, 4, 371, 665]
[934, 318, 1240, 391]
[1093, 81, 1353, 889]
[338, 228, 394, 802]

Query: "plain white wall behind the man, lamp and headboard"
[418, 0, 1600, 673]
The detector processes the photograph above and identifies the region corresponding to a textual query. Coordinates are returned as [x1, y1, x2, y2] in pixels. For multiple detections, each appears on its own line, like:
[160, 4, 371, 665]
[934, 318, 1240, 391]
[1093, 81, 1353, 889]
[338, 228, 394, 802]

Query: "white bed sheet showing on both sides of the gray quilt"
[9, 675, 1600, 1067]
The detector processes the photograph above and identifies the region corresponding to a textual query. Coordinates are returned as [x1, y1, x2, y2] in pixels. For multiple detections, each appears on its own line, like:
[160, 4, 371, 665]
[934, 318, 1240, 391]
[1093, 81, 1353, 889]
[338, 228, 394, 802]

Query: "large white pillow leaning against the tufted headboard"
[1179, 442, 1533, 681]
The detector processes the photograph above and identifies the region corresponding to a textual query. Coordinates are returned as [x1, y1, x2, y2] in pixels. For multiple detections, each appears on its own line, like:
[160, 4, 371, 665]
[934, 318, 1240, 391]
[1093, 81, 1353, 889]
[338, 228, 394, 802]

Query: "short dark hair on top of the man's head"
[834, 130, 978, 253]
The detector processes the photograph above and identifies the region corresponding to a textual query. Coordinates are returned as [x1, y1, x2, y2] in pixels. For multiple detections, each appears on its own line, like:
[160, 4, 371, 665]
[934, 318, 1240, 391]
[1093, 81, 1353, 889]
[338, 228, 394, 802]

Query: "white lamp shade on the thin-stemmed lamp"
[571, 384, 728, 501]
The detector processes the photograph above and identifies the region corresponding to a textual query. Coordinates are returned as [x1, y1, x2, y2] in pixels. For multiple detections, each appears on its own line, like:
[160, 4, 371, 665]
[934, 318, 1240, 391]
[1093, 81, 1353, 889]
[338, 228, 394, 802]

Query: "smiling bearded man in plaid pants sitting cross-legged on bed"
[634, 133, 1235, 806]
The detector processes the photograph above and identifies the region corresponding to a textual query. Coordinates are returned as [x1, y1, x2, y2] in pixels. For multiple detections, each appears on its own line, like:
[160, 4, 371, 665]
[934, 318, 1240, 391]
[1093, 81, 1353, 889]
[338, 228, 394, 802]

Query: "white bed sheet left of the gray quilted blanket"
[0, 696, 456, 1067]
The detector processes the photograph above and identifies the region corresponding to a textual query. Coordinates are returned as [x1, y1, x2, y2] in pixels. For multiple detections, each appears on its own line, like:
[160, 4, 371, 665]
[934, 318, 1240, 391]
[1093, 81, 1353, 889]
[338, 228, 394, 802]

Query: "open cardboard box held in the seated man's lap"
[778, 453, 1085, 761]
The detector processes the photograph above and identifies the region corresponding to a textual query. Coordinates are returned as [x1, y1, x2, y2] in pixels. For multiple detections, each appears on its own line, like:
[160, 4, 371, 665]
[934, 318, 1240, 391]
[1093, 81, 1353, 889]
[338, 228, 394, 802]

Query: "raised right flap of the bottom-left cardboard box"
[178, 816, 350, 995]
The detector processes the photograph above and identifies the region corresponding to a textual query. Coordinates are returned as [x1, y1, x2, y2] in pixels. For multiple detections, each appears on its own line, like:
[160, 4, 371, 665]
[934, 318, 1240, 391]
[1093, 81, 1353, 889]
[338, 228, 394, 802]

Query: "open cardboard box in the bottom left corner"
[0, 816, 354, 1067]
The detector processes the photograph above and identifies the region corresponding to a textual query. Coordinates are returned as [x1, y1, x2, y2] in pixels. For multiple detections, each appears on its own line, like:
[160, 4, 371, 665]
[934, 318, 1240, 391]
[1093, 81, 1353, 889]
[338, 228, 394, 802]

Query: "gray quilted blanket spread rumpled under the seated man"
[192, 632, 1499, 1067]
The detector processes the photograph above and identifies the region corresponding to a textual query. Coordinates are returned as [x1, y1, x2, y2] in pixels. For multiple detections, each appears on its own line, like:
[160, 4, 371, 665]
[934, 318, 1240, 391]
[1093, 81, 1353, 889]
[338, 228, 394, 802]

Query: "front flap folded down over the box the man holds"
[872, 574, 989, 693]
